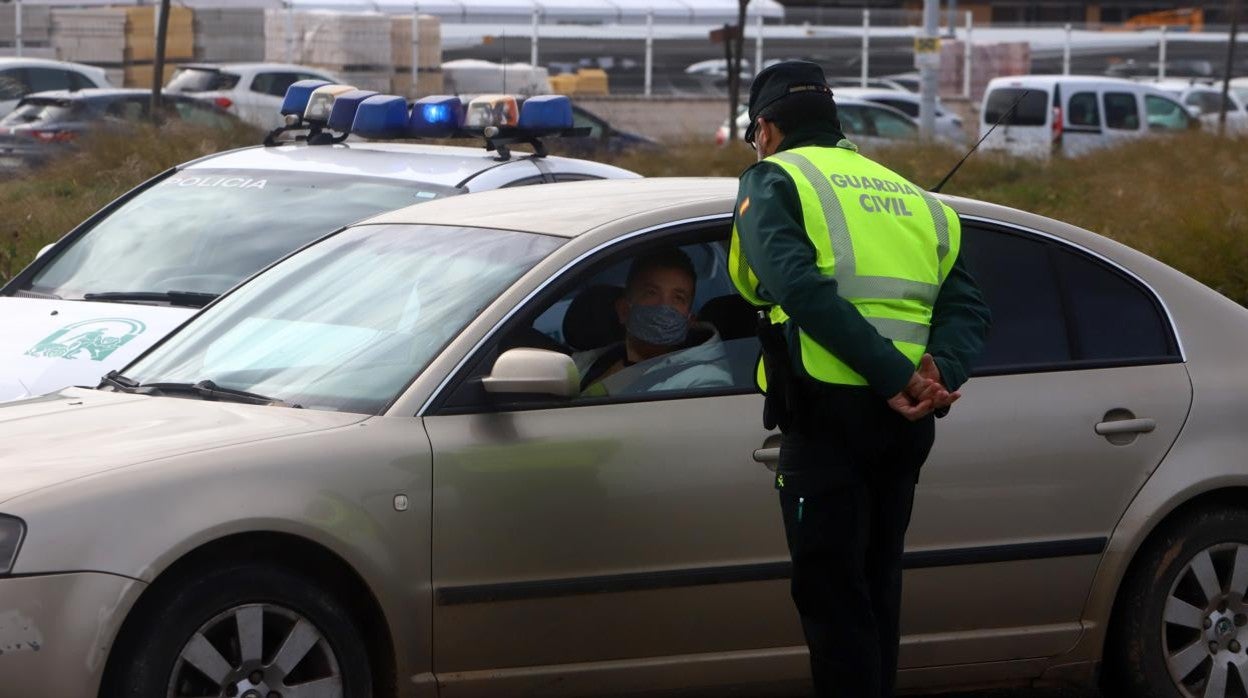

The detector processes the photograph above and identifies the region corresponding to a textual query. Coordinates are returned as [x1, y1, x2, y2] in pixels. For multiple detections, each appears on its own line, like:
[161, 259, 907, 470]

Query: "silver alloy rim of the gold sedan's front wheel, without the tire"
[166, 603, 343, 698]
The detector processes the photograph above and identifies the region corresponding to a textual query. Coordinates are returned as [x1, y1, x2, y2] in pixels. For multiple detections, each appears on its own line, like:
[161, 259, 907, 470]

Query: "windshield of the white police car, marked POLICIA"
[26, 170, 456, 298]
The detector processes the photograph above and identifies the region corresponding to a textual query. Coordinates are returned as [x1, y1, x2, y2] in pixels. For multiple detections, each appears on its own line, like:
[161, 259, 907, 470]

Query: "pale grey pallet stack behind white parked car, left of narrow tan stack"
[265, 10, 394, 92]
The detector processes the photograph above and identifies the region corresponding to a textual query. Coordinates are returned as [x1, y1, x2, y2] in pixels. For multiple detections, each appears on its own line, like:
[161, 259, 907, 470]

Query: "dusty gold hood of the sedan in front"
[0, 388, 367, 503]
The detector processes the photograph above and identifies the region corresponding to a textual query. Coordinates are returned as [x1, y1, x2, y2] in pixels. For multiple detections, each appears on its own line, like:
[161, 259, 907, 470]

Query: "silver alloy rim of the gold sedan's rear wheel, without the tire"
[1162, 543, 1248, 698]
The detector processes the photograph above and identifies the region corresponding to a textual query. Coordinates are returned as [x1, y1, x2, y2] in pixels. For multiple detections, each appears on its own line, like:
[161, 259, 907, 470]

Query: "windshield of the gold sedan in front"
[126, 225, 560, 415]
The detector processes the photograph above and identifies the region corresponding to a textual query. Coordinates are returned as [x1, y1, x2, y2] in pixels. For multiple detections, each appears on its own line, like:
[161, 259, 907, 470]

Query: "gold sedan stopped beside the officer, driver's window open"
[0, 179, 1248, 698]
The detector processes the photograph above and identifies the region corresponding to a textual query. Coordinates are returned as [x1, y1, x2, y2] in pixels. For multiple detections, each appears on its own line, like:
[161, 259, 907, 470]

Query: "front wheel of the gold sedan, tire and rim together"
[102, 563, 372, 698]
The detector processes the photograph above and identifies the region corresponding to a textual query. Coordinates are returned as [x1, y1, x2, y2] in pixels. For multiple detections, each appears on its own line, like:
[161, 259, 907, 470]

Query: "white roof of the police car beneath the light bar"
[182, 142, 635, 187]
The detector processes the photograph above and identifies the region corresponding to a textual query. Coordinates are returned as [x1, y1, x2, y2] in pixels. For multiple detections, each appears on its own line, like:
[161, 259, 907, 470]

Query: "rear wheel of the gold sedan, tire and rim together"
[1103, 508, 1248, 698]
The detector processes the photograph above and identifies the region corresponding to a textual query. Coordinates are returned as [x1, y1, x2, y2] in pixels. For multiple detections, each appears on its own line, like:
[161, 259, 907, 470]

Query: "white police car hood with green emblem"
[0, 296, 196, 402]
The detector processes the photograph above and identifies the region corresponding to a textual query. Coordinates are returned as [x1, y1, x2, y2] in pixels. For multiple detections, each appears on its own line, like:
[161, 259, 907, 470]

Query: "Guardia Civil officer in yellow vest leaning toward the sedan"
[729, 61, 988, 698]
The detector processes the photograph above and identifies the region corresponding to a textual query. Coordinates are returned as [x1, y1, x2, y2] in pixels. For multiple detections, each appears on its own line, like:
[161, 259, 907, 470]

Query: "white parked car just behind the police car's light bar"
[165, 62, 337, 130]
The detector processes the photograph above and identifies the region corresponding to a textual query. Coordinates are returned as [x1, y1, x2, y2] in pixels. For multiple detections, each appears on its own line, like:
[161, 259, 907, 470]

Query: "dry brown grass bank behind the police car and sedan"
[0, 125, 1248, 305]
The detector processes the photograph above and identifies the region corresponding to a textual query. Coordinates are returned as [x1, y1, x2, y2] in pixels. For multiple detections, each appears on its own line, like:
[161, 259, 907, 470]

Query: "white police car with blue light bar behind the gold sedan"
[0, 81, 638, 401]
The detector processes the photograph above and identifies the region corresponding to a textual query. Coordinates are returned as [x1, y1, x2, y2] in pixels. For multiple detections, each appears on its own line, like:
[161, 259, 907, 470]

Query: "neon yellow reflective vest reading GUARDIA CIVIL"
[729, 147, 961, 387]
